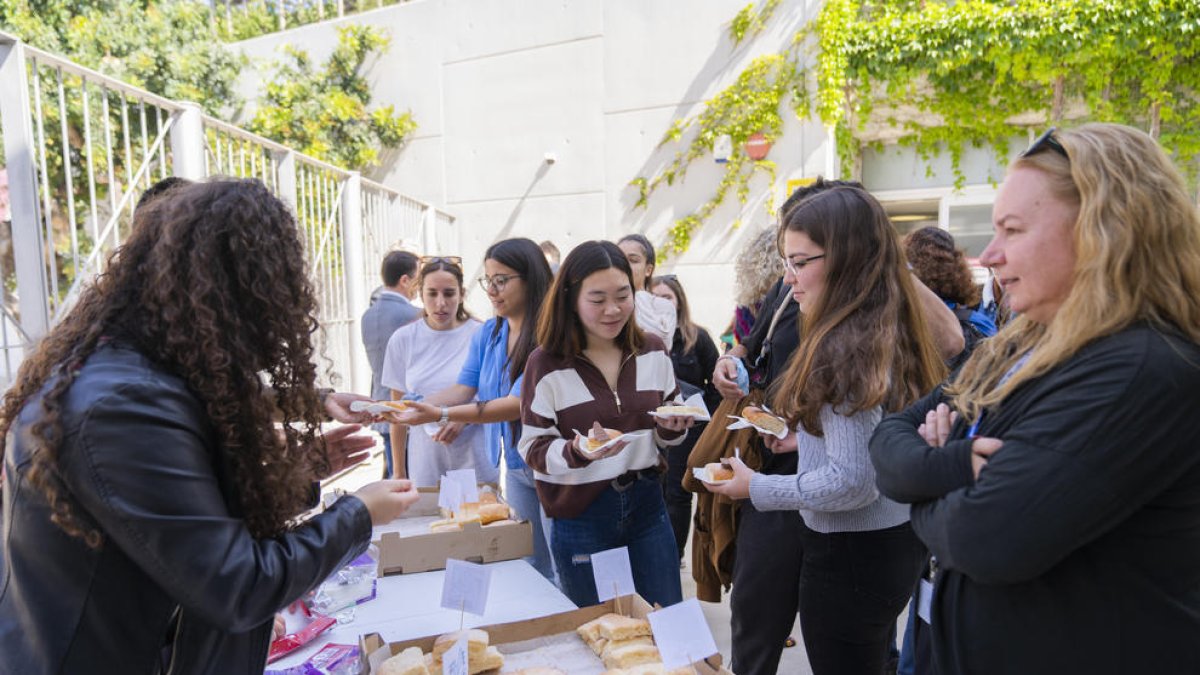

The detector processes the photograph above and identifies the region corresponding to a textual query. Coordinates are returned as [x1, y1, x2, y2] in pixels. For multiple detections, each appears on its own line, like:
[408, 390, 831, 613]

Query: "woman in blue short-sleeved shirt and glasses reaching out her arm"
[400, 238, 554, 580]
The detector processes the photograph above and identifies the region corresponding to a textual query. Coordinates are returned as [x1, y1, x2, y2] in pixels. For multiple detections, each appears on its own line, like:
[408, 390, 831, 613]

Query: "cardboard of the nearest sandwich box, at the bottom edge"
[359, 595, 733, 675]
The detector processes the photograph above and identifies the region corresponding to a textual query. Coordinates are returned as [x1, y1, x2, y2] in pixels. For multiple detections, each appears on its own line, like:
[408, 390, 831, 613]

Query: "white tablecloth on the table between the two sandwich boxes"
[268, 560, 575, 670]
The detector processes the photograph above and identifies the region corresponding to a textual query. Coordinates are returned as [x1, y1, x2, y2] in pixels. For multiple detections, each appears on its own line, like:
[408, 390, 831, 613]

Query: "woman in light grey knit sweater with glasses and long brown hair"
[709, 186, 944, 675]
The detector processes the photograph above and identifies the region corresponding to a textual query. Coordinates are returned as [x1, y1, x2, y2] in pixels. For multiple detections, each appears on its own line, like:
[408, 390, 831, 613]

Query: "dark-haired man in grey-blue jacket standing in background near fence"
[362, 251, 421, 478]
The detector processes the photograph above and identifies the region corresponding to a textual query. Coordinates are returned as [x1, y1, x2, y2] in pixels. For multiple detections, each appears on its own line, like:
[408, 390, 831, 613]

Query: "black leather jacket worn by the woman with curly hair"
[0, 346, 371, 675]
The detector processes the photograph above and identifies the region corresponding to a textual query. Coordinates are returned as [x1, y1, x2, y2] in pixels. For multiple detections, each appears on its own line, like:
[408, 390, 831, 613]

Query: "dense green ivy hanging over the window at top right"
[816, 0, 1200, 185]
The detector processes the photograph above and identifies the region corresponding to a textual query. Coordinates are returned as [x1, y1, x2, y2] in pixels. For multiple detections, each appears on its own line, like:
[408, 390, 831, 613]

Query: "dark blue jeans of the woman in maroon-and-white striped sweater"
[550, 478, 683, 607]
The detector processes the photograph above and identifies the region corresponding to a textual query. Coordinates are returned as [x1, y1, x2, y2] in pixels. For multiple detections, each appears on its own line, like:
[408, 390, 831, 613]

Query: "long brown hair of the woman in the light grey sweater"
[772, 185, 946, 436]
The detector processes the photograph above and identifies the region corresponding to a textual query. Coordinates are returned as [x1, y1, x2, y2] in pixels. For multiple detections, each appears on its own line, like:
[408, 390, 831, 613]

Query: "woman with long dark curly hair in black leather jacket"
[0, 180, 416, 675]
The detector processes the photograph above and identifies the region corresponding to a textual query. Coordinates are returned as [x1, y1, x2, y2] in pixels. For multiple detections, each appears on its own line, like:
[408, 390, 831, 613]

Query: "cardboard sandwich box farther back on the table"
[374, 488, 533, 577]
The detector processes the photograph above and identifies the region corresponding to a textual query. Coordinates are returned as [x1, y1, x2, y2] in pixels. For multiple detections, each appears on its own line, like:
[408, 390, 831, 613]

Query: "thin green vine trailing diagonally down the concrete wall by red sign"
[630, 54, 808, 252]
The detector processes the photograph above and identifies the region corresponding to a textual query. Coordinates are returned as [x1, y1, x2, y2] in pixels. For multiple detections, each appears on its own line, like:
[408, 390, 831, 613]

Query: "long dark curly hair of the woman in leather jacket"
[0, 180, 329, 546]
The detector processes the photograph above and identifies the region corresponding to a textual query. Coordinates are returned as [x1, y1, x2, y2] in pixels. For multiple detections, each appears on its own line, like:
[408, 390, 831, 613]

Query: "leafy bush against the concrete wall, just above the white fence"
[250, 25, 416, 169]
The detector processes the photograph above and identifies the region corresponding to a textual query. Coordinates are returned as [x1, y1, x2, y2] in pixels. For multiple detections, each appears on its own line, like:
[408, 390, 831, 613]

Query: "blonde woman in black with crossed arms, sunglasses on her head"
[871, 124, 1200, 675]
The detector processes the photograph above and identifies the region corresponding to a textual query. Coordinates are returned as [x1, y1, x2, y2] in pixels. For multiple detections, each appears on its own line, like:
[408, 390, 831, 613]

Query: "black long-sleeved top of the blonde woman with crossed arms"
[870, 325, 1200, 675]
